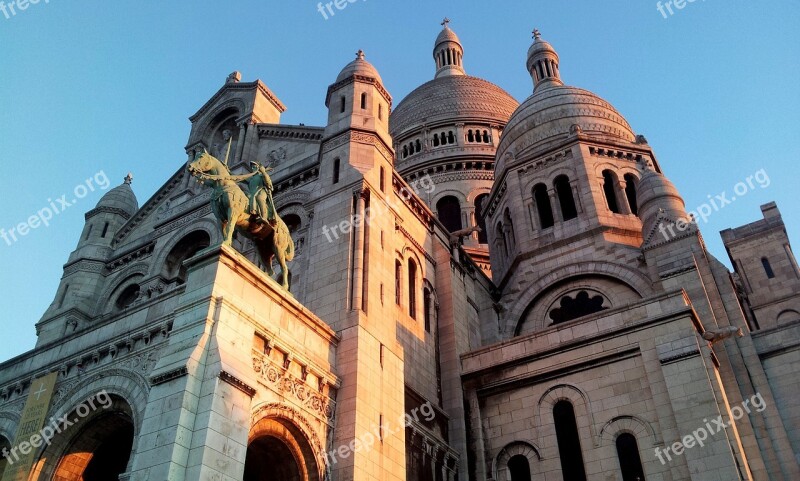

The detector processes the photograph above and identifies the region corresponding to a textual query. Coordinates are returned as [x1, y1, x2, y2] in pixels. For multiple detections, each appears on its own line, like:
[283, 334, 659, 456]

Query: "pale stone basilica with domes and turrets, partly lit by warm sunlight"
[0, 21, 800, 481]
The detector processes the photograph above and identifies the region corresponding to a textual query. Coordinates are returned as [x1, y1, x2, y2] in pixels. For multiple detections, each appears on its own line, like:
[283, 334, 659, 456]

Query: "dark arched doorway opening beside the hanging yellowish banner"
[34, 396, 134, 481]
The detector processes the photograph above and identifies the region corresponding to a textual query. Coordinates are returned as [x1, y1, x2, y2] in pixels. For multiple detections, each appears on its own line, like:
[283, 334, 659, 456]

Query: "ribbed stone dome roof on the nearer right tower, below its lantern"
[498, 84, 635, 162]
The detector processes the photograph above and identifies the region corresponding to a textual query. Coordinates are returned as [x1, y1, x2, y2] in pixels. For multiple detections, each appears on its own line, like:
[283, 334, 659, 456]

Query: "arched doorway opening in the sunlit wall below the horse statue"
[243, 417, 320, 481]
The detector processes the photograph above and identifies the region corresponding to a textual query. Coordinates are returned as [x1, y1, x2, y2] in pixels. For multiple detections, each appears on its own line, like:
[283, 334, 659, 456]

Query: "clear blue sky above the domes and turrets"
[0, 0, 800, 360]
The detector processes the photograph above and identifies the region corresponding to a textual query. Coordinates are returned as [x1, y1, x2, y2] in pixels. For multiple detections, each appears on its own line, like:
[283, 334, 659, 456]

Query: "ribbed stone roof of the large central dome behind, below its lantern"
[389, 75, 519, 139]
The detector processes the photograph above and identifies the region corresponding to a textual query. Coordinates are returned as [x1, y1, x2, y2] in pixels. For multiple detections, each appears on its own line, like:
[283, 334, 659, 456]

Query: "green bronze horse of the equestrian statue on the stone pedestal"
[187, 150, 294, 290]
